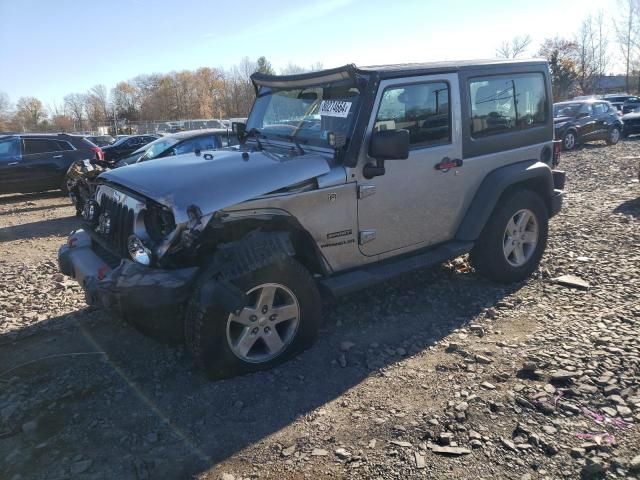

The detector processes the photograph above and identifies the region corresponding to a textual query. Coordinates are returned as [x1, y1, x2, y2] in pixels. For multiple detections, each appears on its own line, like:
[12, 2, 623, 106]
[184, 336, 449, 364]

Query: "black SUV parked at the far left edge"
[0, 133, 102, 193]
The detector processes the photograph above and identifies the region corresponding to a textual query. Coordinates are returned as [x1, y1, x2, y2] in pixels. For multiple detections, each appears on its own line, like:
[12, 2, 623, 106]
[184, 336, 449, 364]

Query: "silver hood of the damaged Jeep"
[100, 150, 330, 223]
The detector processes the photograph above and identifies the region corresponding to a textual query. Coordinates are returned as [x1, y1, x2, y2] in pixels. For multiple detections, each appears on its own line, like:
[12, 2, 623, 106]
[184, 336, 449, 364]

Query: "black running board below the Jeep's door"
[320, 242, 473, 297]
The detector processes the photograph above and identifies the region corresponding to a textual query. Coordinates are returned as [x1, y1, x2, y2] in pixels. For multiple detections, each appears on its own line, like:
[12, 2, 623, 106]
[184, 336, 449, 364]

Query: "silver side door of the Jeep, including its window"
[356, 74, 464, 256]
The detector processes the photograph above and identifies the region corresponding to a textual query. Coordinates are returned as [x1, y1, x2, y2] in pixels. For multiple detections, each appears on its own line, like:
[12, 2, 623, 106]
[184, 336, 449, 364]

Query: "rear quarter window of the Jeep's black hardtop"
[469, 73, 548, 137]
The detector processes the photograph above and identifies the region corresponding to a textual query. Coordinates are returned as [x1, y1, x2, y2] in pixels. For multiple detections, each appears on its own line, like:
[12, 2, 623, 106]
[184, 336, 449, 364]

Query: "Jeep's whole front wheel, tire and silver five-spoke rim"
[185, 258, 321, 378]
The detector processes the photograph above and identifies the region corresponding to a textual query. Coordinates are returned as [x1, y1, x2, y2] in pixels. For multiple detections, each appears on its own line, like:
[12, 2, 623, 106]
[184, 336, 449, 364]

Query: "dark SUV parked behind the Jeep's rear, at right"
[553, 99, 622, 150]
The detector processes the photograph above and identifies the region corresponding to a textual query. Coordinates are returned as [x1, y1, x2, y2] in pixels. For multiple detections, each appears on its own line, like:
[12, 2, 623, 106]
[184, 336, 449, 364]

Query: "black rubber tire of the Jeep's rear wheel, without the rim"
[470, 189, 549, 283]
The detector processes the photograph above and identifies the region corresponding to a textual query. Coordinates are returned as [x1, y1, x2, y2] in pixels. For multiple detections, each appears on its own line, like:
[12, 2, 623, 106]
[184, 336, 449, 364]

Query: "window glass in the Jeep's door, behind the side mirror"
[373, 82, 451, 147]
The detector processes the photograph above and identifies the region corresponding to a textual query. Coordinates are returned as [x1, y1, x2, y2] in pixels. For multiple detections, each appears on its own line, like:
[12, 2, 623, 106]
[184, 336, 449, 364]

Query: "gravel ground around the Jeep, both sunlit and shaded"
[0, 140, 640, 480]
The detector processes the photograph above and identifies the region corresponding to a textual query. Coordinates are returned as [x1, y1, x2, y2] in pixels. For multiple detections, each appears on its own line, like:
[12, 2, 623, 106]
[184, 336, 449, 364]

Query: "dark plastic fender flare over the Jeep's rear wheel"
[456, 160, 554, 241]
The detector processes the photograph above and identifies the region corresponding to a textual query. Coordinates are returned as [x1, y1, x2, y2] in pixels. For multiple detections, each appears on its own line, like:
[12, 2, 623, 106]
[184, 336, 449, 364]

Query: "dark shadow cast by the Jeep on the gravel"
[0, 266, 518, 479]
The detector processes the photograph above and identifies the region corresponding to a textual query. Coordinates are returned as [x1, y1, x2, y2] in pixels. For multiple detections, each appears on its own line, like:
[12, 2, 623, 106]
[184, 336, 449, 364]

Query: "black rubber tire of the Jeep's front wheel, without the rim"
[184, 257, 322, 379]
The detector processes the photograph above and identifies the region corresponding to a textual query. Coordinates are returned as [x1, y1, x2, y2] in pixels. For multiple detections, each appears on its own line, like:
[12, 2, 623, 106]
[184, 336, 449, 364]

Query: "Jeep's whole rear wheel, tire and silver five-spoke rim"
[471, 190, 549, 283]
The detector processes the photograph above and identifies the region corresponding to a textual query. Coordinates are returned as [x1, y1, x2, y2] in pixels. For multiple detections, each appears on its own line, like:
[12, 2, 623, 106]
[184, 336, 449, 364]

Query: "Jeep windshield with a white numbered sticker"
[247, 81, 360, 147]
